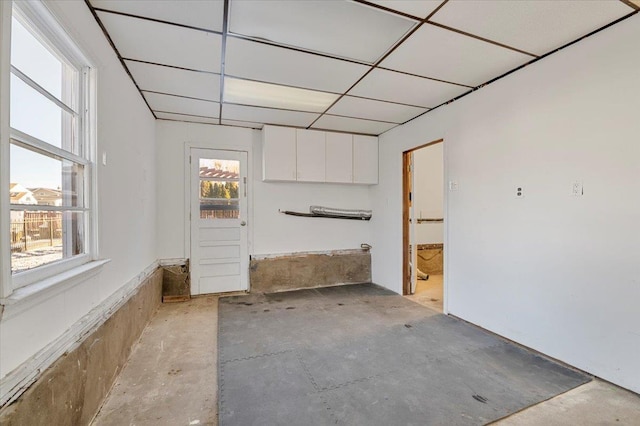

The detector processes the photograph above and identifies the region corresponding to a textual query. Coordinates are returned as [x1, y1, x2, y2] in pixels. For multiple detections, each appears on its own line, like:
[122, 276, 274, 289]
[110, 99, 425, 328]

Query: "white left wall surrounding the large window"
[0, 2, 156, 377]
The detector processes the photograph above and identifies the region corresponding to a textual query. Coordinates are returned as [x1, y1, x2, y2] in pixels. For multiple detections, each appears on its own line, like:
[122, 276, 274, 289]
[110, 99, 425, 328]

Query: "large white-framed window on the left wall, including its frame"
[3, 2, 95, 289]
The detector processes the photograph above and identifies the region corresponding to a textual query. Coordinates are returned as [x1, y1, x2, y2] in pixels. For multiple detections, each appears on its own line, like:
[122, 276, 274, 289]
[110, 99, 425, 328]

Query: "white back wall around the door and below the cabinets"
[156, 120, 371, 259]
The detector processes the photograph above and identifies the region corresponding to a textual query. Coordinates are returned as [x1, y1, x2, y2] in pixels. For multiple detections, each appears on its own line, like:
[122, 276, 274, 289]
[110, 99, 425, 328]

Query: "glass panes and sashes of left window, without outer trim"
[9, 8, 89, 274]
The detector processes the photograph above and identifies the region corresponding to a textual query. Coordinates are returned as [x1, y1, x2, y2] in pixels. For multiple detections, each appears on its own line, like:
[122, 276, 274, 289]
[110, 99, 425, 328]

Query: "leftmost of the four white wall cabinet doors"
[262, 126, 296, 181]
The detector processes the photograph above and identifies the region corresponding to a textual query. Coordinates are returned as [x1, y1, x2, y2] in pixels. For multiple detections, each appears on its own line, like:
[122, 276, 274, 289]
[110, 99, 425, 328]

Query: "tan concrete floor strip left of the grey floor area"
[92, 296, 218, 426]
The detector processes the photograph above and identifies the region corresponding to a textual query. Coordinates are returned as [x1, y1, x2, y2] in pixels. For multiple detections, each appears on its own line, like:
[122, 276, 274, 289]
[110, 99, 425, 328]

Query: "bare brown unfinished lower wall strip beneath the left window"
[0, 269, 162, 426]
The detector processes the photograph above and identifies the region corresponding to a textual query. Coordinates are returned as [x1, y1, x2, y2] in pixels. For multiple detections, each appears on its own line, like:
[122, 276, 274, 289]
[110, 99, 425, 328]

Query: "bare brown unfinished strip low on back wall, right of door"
[249, 250, 371, 293]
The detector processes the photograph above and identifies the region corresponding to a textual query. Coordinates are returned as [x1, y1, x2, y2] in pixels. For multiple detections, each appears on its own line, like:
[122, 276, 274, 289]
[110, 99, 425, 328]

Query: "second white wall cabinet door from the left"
[296, 129, 325, 182]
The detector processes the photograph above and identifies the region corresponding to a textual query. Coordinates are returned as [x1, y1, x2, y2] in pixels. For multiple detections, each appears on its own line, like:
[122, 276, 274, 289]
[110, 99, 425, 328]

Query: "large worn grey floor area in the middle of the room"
[218, 284, 590, 425]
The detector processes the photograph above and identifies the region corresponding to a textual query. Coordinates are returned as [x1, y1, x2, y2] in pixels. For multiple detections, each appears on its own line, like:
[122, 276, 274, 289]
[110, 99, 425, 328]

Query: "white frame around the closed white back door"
[182, 142, 254, 292]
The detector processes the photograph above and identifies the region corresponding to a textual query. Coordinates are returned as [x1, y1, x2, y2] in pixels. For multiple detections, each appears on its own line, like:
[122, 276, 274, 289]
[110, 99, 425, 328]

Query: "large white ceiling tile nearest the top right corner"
[431, 0, 633, 55]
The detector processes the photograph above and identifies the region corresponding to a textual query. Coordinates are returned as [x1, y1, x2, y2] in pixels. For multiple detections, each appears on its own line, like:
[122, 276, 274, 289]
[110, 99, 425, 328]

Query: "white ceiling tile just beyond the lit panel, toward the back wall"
[222, 104, 319, 127]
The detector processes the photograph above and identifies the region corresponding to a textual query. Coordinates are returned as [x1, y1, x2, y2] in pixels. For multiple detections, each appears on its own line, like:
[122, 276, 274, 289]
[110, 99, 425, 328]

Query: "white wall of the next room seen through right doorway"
[412, 143, 444, 244]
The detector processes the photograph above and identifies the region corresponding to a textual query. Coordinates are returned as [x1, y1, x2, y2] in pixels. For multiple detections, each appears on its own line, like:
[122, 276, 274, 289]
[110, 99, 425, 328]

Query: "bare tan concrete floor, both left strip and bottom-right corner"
[93, 288, 640, 426]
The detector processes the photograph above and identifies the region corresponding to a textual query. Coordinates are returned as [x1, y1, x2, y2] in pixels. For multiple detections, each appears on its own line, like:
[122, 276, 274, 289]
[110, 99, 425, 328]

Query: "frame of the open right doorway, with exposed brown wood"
[401, 139, 449, 298]
